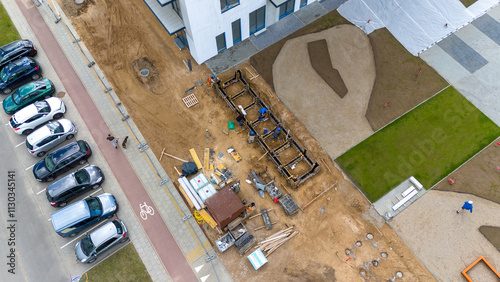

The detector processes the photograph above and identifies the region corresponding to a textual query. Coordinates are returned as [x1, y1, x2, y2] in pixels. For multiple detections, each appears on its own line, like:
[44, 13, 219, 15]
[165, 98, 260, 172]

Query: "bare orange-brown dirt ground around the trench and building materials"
[59, 0, 433, 281]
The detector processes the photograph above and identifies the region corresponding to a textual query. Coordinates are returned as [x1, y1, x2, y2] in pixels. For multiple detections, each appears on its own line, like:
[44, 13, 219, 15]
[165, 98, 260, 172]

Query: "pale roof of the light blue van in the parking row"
[51, 199, 90, 231]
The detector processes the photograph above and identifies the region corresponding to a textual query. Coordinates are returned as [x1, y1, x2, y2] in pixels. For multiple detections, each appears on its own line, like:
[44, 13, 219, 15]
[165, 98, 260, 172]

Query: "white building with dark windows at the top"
[144, 0, 317, 64]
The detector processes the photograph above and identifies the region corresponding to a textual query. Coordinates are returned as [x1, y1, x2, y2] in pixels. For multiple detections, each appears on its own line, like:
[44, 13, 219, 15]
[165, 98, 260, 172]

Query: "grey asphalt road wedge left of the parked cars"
[0, 119, 70, 281]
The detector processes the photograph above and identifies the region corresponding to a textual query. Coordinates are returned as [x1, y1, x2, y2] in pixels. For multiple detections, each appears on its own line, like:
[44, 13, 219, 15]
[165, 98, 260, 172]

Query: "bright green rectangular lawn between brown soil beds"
[336, 86, 500, 202]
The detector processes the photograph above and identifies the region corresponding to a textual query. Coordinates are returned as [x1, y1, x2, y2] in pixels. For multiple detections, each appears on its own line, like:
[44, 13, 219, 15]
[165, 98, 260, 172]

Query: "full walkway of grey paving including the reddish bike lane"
[3, 0, 231, 281]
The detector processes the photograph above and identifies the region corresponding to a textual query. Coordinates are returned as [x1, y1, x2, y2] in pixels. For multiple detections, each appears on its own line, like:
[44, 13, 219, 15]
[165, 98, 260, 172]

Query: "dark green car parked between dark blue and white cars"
[2, 78, 56, 115]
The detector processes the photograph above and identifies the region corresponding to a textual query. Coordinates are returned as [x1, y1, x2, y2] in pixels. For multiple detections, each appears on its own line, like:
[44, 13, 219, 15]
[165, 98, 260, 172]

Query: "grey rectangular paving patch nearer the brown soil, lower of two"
[437, 34, 488, 73]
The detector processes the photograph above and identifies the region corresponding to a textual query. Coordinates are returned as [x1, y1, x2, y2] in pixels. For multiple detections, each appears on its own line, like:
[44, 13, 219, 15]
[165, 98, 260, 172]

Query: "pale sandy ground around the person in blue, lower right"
[391, 190, 500, 281]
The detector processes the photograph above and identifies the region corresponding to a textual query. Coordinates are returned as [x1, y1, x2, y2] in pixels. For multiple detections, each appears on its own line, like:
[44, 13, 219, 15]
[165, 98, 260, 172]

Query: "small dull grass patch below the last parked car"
[82, 244, 152, 282]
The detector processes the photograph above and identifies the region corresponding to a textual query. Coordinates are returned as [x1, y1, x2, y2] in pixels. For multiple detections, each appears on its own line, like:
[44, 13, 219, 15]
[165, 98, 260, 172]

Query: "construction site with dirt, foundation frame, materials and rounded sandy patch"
[53, 0, 496, 281]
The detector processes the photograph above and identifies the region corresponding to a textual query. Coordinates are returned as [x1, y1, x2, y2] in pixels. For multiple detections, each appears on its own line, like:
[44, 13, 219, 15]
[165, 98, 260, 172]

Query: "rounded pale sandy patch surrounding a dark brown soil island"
[273, 25, 375, 159]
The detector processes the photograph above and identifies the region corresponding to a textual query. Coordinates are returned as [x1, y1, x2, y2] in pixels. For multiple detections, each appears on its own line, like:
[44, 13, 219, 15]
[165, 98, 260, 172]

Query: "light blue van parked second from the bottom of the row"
[50, 193, 118, 237]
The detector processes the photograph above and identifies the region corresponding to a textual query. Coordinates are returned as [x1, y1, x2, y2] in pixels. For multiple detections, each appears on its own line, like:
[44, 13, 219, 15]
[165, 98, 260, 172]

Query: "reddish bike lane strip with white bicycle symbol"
[16, 0, 198, 281]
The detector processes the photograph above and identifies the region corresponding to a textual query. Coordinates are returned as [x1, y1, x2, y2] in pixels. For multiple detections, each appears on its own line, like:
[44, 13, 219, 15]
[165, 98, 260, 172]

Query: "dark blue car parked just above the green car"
[0, 57, 42, 94]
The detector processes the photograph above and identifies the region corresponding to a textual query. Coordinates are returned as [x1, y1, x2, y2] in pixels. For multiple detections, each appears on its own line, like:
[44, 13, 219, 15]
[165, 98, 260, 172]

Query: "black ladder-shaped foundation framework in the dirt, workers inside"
[213, 70, 320, 188]
